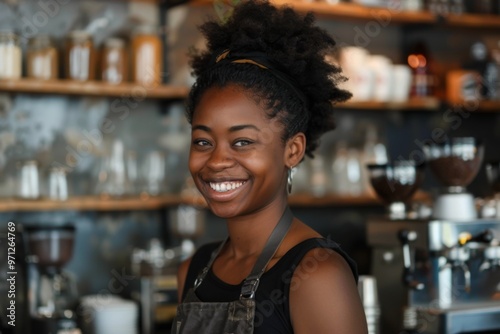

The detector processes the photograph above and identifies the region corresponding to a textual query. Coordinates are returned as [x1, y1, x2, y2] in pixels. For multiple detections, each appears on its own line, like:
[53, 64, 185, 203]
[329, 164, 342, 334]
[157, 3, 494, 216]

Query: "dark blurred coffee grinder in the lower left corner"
[26, 225, 81, 334]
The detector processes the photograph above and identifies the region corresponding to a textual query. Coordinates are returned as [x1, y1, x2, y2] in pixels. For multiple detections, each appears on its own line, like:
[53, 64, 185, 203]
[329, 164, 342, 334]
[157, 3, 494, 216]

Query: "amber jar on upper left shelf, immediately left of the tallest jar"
[101, 38, 127, 84]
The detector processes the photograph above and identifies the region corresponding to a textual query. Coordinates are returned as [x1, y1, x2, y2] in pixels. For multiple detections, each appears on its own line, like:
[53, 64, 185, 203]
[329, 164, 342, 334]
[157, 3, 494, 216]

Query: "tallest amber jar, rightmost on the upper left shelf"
[132, 25, 163, 86]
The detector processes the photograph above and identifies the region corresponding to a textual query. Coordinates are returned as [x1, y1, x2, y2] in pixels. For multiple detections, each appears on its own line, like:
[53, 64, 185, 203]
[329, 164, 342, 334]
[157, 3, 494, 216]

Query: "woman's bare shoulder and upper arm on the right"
[290, 248, 367, 334]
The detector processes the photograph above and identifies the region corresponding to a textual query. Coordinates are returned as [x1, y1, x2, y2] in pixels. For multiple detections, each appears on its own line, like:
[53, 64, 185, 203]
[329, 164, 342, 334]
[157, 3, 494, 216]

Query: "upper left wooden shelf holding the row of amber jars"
[0, 79, 188, 100]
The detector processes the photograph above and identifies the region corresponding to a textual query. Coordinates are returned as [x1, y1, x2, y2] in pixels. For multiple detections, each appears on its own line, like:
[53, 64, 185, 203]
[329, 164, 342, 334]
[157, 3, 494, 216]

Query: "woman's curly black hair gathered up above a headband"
[187, 0, 351, 157]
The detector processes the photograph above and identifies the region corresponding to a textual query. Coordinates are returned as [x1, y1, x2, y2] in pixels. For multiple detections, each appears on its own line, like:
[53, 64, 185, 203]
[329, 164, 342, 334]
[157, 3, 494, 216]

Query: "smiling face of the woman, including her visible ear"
[189, 86, 305, 218]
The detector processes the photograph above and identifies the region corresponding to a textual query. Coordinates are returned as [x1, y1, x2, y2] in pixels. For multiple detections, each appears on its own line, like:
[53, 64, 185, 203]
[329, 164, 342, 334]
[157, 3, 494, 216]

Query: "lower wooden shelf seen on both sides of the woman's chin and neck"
[0, 192, 429, 212]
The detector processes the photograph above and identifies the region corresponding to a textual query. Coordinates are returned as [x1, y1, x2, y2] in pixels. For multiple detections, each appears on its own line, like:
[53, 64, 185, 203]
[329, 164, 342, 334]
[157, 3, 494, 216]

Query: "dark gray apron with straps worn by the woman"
[172, 207, 293, 334]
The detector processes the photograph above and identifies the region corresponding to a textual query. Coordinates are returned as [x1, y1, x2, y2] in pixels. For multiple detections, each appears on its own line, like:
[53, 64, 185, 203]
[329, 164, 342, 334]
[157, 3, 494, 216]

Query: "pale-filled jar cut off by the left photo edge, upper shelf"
[0, 31, 22, 79]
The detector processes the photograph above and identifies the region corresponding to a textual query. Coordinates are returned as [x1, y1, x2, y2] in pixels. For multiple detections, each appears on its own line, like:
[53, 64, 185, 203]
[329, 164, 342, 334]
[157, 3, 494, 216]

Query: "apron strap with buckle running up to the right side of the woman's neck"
[240, 206, 293, 300]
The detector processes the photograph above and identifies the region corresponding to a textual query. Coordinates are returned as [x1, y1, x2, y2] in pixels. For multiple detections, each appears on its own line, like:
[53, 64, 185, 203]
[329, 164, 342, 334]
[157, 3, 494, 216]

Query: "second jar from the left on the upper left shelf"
[26, 35, 59, 80]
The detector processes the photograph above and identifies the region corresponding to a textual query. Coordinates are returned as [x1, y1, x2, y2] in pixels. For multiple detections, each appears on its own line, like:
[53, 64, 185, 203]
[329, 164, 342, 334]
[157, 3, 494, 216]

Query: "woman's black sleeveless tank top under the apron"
[182, 238, 358, 334]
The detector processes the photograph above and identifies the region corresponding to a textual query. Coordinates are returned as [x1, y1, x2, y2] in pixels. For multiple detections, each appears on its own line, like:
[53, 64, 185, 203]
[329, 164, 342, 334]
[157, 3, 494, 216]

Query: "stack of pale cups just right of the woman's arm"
[358, 275, 380, 334]
